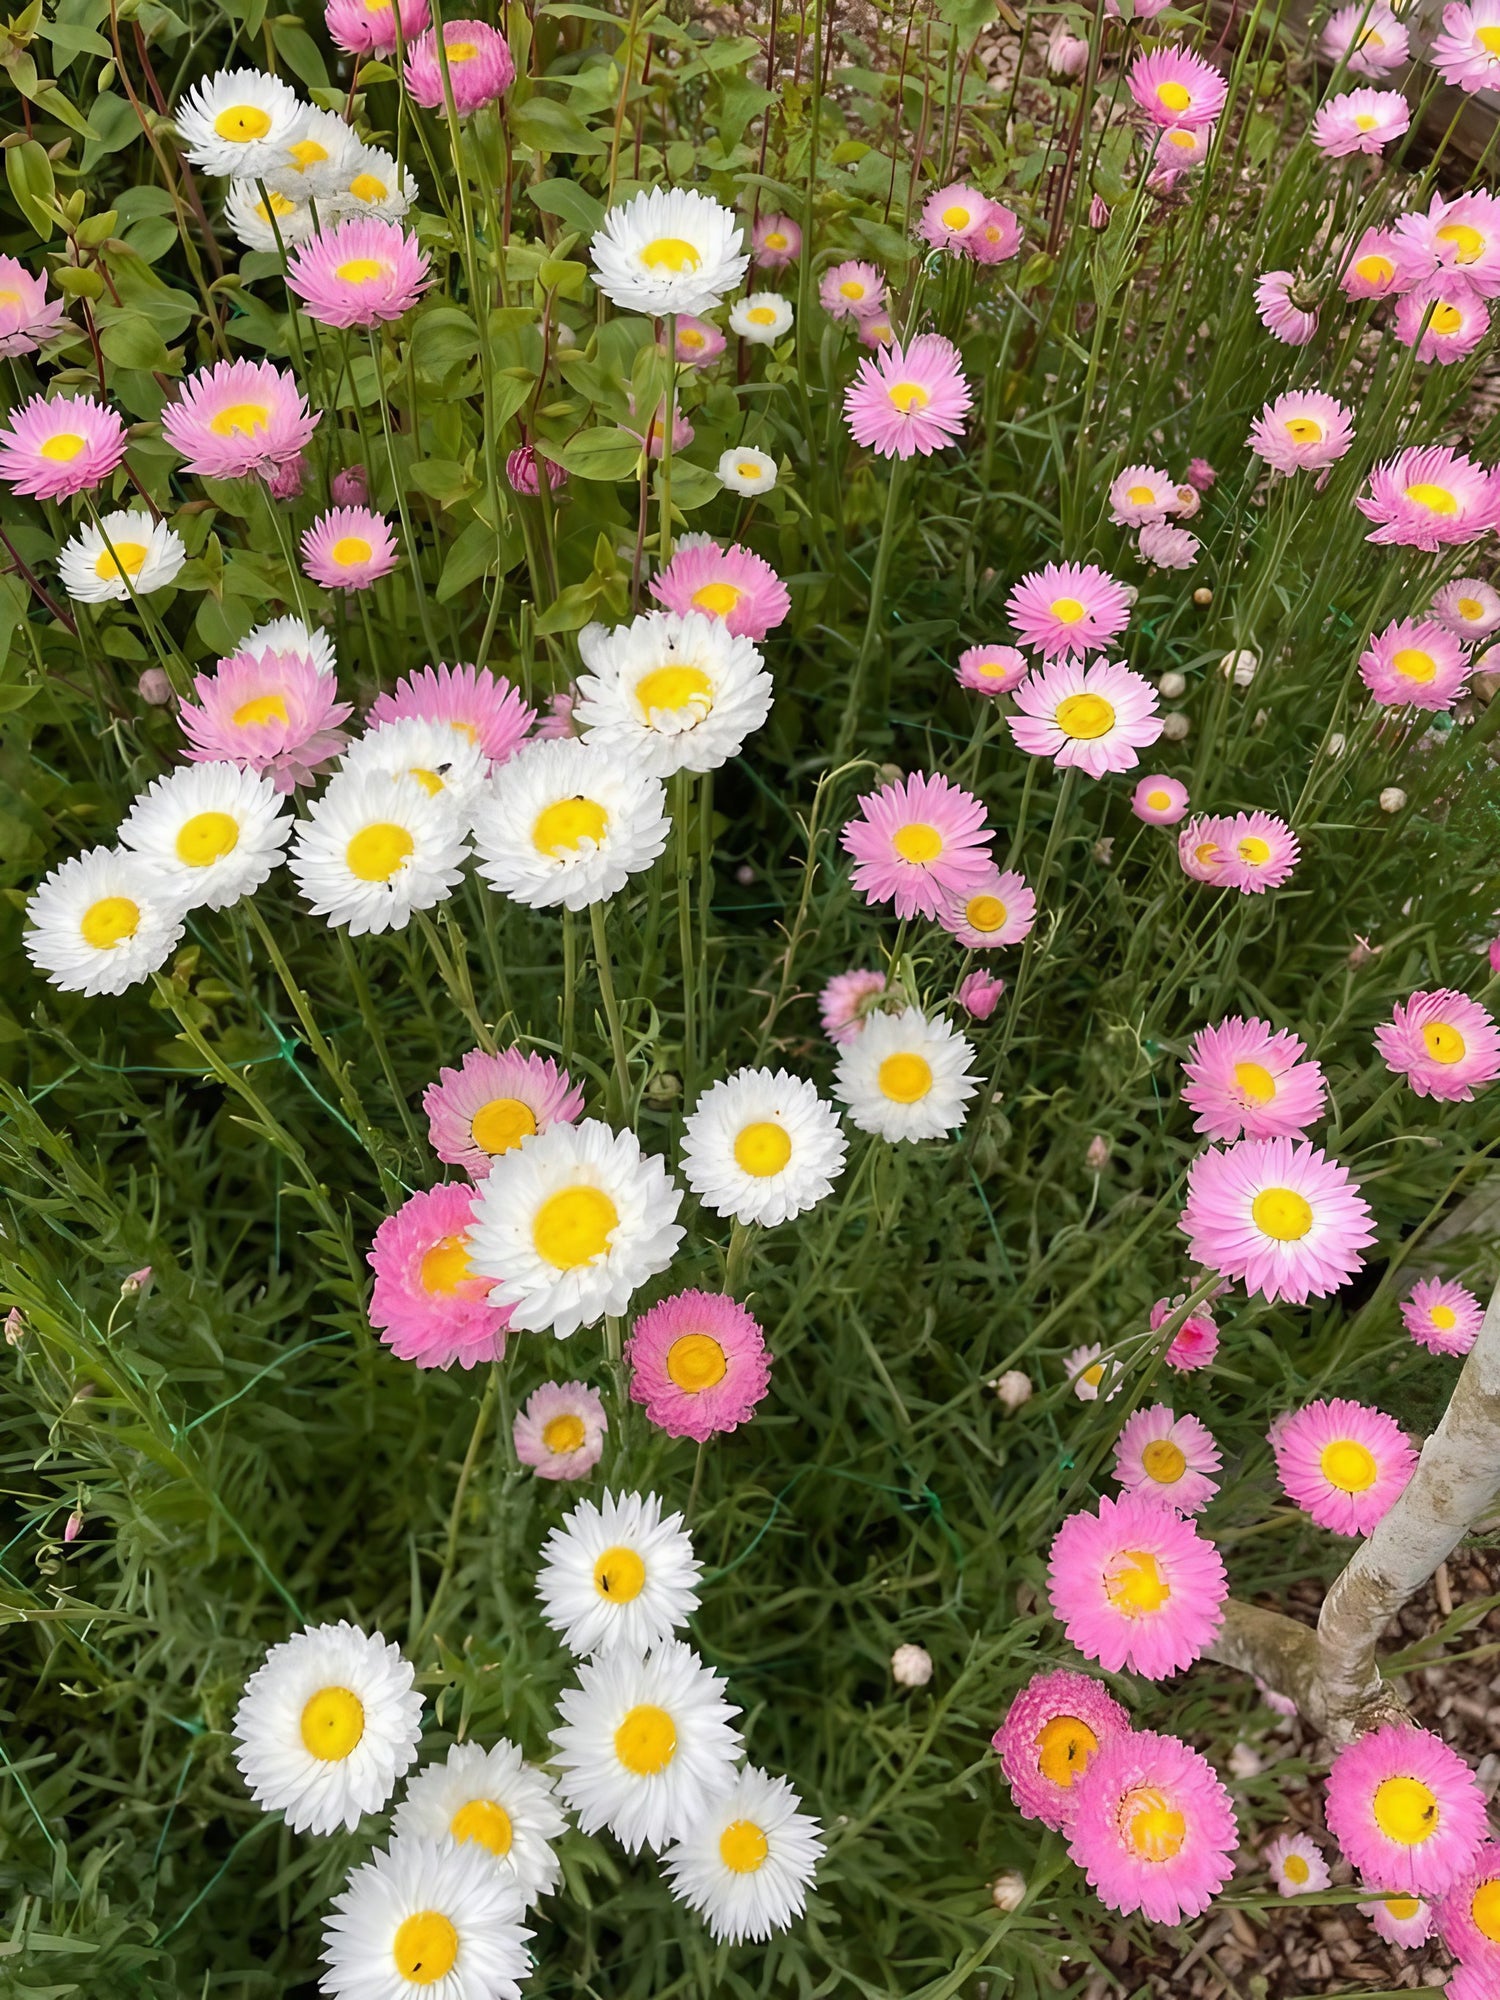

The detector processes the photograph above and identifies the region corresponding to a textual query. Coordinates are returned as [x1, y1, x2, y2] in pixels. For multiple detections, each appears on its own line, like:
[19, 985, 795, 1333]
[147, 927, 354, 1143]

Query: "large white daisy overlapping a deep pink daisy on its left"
[468, 1118, 682, 1340]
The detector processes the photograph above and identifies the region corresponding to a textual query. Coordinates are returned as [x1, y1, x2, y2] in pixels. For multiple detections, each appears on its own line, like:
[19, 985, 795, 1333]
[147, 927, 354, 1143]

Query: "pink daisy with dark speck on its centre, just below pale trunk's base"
[1324, 1722, 1486, 1896]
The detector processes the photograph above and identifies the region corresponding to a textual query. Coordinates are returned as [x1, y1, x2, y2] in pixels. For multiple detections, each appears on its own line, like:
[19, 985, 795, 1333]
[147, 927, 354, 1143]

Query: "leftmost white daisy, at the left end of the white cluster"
[24, 848, 182, 998]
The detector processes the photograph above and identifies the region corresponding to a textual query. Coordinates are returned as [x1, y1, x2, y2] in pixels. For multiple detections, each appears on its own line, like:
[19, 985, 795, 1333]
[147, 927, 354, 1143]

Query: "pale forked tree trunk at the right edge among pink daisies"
[1208, 1286, 1500, 1744]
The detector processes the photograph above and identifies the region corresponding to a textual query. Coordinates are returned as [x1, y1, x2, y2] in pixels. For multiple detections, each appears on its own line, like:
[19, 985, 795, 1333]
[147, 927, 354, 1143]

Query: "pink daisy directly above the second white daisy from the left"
[178, 646, 350, 792]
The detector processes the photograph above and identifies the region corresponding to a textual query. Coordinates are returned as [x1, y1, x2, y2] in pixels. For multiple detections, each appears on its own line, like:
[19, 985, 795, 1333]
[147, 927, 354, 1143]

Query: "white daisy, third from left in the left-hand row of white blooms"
[286, 772, 468, 938]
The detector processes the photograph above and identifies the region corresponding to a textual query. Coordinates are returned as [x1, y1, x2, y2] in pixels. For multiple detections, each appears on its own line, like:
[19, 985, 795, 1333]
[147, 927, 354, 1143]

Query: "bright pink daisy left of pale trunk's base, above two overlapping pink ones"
[1048, 1494, 1228, 1680]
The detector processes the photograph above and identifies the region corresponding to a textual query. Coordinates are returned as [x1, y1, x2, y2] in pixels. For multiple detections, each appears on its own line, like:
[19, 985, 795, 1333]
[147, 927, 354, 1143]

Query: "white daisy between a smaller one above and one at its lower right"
[552, 1638, 742, 1854]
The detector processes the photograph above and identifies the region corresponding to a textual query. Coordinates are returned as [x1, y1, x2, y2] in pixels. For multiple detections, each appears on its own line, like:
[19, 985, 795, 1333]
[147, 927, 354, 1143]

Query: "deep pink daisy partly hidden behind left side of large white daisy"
[366, 1180, 510, 1368]
